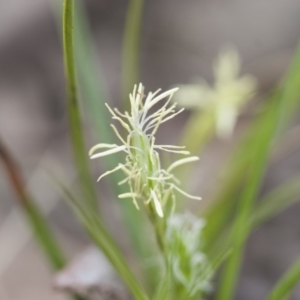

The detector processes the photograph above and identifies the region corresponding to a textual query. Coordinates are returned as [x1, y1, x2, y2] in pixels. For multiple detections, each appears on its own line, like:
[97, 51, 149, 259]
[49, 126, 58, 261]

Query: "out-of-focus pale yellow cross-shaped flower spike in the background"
[174, 47, 256, 138]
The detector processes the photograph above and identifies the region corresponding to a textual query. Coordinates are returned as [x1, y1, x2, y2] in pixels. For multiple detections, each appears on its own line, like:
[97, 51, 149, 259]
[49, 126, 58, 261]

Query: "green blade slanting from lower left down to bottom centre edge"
[54, 178, 148, 300]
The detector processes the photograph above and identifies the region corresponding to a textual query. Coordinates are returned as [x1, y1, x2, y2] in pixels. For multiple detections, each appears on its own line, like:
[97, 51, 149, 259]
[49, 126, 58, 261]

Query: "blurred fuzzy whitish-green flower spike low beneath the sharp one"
[166, 212, 213, 299]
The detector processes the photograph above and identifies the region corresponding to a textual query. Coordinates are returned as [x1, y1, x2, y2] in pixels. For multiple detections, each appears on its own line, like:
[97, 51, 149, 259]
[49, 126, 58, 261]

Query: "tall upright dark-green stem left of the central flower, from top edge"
[63, 0, 97, 209]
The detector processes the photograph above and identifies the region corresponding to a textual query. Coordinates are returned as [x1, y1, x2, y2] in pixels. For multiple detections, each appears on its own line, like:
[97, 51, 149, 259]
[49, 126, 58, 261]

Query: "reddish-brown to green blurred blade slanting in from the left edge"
[0, 141, 65, 270]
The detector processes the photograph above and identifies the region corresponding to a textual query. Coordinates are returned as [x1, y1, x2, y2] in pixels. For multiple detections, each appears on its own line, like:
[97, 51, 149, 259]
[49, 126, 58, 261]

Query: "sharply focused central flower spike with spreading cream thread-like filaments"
[89, 84, 201, 217]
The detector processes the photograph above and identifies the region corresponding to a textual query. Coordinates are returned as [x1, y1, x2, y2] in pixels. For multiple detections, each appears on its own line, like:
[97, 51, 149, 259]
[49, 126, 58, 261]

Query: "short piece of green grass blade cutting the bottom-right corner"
[265, 258, 300, 300]
